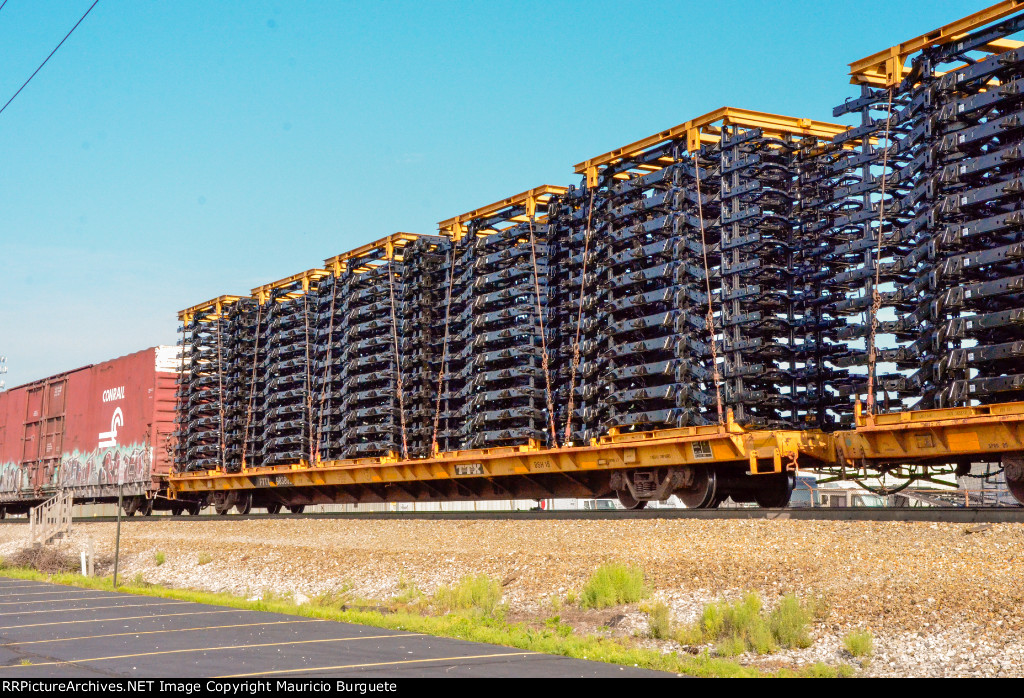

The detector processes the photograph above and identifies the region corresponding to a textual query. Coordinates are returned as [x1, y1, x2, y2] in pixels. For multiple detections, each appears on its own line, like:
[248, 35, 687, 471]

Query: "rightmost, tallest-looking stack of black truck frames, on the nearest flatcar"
[826, 9, 1024, 410]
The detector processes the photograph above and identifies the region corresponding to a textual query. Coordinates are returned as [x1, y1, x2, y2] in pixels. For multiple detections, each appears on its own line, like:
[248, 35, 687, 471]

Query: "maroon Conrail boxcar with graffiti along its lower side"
[0, 347, 180, 512]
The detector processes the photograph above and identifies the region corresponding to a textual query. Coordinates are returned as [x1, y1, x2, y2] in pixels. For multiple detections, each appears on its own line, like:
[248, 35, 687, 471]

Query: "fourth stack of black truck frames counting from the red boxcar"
[440, 186, 564, 450]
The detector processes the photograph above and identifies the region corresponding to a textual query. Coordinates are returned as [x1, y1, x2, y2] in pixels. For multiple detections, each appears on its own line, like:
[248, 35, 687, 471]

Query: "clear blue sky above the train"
[0, 0, 990, 387]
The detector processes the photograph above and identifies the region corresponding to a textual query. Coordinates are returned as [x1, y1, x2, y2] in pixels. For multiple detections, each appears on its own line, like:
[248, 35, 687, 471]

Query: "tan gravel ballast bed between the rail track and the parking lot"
[0, 518, 1024, 677]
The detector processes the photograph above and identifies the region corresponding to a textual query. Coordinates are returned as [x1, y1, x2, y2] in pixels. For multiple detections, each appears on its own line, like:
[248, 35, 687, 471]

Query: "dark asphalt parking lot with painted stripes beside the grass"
[0, 577, 671, 680]
